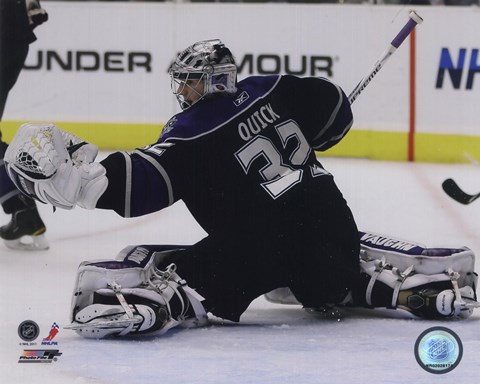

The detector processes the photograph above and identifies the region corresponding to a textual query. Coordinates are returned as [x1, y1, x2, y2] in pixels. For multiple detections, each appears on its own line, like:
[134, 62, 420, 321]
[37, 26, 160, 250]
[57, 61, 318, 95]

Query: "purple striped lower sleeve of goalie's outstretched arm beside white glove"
[96, 149, 174, 217]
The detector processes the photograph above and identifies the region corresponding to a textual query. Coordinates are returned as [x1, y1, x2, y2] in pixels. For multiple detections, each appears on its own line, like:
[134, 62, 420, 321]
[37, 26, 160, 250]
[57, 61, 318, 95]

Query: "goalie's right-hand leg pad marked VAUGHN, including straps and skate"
[265, 232, 480, 319]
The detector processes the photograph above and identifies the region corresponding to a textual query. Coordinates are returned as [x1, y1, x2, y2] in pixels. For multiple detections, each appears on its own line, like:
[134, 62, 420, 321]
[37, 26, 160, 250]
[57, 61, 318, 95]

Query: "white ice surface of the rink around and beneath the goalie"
[0, 154, 480, 384]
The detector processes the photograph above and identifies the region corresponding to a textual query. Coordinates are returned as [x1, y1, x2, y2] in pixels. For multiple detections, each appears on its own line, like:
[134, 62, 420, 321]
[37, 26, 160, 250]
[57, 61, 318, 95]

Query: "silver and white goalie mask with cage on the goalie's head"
[168, 39, 237, 110]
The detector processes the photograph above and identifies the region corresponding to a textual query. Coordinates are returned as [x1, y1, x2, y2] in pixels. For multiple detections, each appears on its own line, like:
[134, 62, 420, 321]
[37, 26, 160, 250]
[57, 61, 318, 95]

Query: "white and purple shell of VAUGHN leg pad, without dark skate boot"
[360, 232, 478, 317]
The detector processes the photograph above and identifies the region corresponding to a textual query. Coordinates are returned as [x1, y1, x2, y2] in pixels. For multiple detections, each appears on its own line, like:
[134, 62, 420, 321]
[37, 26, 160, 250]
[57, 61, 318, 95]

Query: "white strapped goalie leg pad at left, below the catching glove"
[66, 247, 208, 338]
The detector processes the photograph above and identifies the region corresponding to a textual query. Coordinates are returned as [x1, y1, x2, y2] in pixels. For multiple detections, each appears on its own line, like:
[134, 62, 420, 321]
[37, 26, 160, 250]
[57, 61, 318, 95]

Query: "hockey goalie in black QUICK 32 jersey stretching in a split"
[5, 39, 478, 338]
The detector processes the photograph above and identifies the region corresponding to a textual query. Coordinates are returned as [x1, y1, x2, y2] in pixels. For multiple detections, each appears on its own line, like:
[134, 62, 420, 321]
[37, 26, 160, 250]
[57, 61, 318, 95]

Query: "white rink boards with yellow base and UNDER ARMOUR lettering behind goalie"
[2, 1, 480, 162]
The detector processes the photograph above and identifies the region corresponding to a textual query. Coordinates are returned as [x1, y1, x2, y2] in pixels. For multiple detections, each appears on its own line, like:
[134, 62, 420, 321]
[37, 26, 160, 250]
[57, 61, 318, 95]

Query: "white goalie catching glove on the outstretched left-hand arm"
[4, 124, 108, 209]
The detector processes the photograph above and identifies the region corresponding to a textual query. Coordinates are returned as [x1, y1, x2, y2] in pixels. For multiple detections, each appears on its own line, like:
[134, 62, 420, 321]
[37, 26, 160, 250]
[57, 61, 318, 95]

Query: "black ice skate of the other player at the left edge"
[0, 207, 49, 251]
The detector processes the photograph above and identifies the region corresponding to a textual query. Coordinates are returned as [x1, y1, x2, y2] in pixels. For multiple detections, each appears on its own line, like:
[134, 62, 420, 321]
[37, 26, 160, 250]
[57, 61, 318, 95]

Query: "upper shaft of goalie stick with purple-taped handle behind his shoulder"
[348, 11, 423, 104]
